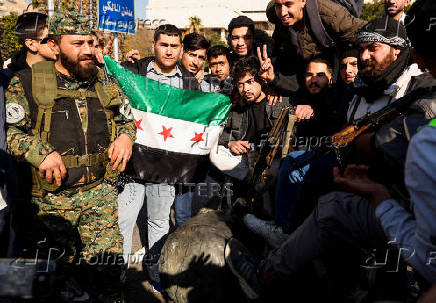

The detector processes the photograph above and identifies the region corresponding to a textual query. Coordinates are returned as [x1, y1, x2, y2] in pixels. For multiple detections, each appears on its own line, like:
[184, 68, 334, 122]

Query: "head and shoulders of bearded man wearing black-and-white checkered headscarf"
[347, 17, 420, 122]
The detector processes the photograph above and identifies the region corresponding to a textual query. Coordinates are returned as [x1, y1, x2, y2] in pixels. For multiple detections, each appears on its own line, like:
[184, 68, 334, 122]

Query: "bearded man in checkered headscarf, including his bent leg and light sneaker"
[246, 17, 434, 246]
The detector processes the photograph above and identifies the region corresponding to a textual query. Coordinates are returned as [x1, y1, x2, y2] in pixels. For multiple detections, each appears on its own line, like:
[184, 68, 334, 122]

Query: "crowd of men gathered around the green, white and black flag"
[0, 0, 436, 302]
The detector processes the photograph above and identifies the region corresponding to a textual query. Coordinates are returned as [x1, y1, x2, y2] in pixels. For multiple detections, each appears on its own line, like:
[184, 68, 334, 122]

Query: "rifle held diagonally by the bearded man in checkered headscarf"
[289, 86, 436, 172]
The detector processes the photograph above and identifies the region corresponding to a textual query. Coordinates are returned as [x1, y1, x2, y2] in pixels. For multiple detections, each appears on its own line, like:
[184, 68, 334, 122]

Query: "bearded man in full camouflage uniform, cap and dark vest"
[6, 12, 136, 302]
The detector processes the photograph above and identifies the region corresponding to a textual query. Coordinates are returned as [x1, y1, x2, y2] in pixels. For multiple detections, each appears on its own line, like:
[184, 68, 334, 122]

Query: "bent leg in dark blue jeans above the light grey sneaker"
[274, 151, 337, 233]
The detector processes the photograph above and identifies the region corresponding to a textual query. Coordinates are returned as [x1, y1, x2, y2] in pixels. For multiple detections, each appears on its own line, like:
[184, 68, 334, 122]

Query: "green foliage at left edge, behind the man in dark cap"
[0, 13, 21, 60]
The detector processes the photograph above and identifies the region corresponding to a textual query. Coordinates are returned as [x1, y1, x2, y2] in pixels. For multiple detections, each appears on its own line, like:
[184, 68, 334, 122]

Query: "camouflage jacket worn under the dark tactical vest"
[5, 72, 136, 167]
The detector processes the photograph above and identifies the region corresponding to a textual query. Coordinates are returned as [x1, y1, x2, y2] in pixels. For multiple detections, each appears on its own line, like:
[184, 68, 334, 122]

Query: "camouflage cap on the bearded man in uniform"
[48, 11, 91, 35]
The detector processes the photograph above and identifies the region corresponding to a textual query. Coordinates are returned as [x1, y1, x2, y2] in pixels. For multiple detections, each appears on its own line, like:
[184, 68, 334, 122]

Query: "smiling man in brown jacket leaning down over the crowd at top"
[265, 0, 366, 93]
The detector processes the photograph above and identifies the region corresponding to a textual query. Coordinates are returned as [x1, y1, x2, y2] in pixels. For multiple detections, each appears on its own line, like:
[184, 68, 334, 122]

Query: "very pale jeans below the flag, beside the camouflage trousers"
[118, 183, 175, 262]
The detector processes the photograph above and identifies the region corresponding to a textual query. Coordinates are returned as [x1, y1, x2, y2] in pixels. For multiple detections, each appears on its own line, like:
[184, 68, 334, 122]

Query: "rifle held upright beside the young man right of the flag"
[247, 106, 295, 202]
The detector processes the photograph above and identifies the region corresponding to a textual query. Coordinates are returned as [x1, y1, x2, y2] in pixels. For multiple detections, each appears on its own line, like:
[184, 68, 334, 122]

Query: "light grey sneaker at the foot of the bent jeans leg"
[242, 214, 289, 248]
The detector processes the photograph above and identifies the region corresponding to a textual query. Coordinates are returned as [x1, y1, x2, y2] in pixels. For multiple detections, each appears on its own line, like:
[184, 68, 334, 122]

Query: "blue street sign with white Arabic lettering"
[98, 0, 135, 34]
